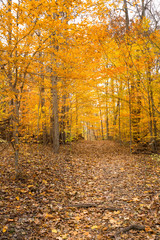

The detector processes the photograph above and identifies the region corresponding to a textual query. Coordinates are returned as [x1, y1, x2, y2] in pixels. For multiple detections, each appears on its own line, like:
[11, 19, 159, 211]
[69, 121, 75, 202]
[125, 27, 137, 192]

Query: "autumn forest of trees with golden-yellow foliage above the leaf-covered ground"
[0, 0, 160, 164]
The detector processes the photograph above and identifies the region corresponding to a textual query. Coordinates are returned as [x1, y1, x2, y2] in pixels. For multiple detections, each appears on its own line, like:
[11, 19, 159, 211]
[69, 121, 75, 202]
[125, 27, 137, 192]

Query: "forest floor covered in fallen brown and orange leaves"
[0, 141, 160, 240]
